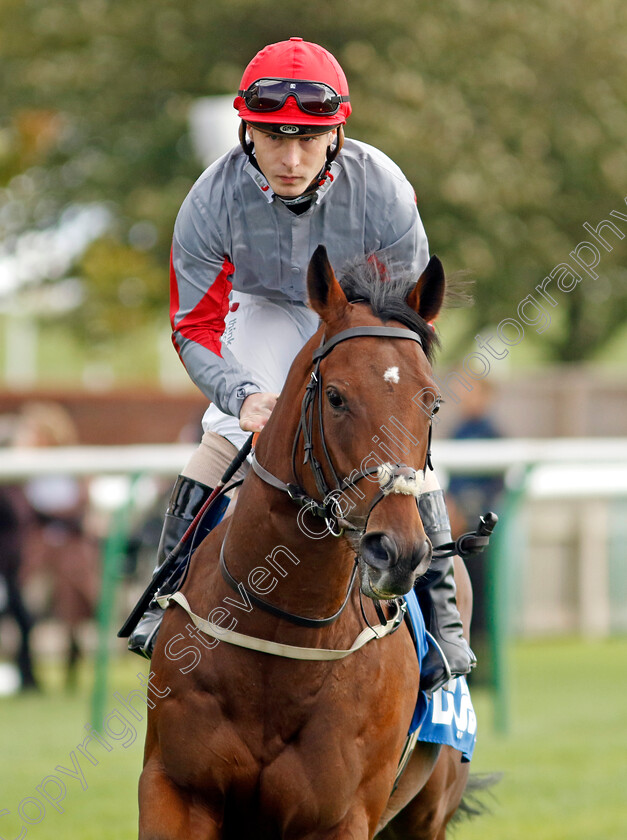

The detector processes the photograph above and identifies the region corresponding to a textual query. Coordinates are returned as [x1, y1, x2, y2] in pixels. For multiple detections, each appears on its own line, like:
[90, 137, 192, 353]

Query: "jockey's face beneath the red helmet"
[248, 126, 337, 198]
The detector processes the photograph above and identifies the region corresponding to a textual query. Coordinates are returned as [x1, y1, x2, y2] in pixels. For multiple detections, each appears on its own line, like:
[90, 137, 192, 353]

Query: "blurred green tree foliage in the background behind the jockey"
[0, 0, 627, 380]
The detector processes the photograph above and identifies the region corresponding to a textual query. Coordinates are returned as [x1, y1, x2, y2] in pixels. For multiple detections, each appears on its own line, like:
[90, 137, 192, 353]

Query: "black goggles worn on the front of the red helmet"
[239, 78, 350, 116]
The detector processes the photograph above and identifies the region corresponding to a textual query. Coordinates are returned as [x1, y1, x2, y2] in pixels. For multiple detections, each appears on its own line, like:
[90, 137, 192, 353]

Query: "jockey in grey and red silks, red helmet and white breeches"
[129, 38, 475, 687]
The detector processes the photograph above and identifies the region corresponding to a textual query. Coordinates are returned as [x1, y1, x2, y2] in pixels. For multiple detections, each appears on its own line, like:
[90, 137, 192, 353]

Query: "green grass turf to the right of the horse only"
[458, 638, 627, 840]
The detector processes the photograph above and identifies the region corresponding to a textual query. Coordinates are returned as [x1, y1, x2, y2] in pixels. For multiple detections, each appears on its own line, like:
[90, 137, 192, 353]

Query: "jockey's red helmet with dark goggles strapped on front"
[233, 38, 351, 135]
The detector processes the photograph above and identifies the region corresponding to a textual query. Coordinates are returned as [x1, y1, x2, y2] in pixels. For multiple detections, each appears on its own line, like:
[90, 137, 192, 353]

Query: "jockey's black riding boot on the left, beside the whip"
[128, 475, 229, 659]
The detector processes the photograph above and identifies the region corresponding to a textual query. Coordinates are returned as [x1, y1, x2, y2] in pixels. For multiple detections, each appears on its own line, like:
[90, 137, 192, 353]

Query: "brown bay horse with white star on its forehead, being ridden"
[139, 247, 471, 840]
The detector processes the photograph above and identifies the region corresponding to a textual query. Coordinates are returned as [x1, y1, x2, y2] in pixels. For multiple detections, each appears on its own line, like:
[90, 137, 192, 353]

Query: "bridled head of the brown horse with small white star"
[299, 246, 445, 598]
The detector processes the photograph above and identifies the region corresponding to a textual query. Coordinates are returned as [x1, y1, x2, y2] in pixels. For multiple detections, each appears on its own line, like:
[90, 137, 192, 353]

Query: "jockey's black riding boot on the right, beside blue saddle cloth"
[416, 490, 477, 692]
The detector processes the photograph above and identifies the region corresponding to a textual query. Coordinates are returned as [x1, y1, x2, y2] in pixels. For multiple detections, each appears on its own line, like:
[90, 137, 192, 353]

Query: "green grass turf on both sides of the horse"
[0, 638, 627, 840]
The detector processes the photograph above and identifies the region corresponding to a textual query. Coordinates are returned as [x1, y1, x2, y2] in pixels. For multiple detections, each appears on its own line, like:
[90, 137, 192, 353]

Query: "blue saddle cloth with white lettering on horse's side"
[404, 589, 477, 761]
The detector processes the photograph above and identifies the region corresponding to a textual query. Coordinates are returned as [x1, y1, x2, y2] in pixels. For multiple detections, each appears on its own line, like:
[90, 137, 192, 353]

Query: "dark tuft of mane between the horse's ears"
[338, 256, 440, 362]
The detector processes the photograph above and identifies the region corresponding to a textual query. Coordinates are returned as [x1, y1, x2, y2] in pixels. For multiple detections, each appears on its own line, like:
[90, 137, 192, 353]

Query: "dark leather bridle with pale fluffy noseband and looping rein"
[220, 326, 433, 627]
